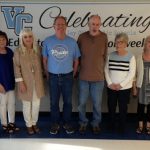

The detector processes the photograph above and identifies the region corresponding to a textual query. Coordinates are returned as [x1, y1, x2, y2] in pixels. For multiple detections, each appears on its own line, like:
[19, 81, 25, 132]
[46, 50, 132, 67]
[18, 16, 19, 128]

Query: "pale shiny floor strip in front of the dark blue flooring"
[0, 139, 150, 150]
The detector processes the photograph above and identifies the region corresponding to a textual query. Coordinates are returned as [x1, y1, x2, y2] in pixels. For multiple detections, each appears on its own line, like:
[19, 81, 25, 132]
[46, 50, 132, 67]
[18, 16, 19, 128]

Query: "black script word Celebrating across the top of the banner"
[39, 6, 150, 33]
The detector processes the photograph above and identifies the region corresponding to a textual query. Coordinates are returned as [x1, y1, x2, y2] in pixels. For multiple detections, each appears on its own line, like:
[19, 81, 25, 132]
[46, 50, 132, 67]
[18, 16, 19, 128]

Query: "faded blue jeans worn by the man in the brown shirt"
[78, 80, 104, 127]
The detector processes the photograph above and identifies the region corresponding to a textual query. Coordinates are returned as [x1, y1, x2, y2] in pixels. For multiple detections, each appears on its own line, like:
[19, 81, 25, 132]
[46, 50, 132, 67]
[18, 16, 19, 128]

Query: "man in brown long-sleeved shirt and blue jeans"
[78, 15, 108, 134]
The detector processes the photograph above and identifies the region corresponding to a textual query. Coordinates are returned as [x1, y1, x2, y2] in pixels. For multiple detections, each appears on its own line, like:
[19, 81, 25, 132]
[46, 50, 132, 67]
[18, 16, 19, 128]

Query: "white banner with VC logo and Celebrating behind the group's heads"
[0, 2, 150, 53]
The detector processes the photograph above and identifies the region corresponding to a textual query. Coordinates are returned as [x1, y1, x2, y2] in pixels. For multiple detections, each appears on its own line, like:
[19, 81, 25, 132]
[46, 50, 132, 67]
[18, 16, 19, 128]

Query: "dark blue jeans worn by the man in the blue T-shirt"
[49, 72, 73, 123]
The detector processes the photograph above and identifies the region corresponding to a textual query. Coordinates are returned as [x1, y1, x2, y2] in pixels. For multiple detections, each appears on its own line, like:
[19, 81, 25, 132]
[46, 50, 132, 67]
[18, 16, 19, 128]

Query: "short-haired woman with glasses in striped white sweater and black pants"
[105, 33, 136, 132]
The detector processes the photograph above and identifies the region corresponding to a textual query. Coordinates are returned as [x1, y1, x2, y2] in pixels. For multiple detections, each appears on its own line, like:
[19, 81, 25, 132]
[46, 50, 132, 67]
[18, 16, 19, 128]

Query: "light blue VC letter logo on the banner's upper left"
[1, 6, 33, 35]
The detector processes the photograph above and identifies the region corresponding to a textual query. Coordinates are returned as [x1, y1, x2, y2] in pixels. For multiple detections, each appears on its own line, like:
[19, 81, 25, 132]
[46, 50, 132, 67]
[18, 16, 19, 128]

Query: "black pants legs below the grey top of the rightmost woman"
[137, 103, 150, 122]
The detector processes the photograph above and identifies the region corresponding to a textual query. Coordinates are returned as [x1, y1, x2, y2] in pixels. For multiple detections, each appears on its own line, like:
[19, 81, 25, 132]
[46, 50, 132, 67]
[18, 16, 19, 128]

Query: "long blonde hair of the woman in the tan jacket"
[19, 28, 38, 53]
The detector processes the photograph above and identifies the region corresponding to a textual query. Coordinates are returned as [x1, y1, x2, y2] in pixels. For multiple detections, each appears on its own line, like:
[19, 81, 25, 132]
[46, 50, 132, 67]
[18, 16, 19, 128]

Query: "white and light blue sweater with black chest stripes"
[105, 51, 136, 90]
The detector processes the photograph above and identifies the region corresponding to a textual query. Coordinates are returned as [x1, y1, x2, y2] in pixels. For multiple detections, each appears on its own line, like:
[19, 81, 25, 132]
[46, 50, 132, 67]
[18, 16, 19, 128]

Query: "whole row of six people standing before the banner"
[0, 15, 150, 135]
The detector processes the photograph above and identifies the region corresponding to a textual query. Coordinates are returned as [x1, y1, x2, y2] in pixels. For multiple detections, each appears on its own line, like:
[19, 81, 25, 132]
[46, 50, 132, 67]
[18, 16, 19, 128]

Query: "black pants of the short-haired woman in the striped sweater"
[107, 88, 130, 129]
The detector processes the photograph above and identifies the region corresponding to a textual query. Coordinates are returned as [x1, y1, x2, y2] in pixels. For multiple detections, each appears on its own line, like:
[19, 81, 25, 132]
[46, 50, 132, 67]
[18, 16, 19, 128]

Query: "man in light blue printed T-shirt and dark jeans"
[42, 16, 80, 134]
